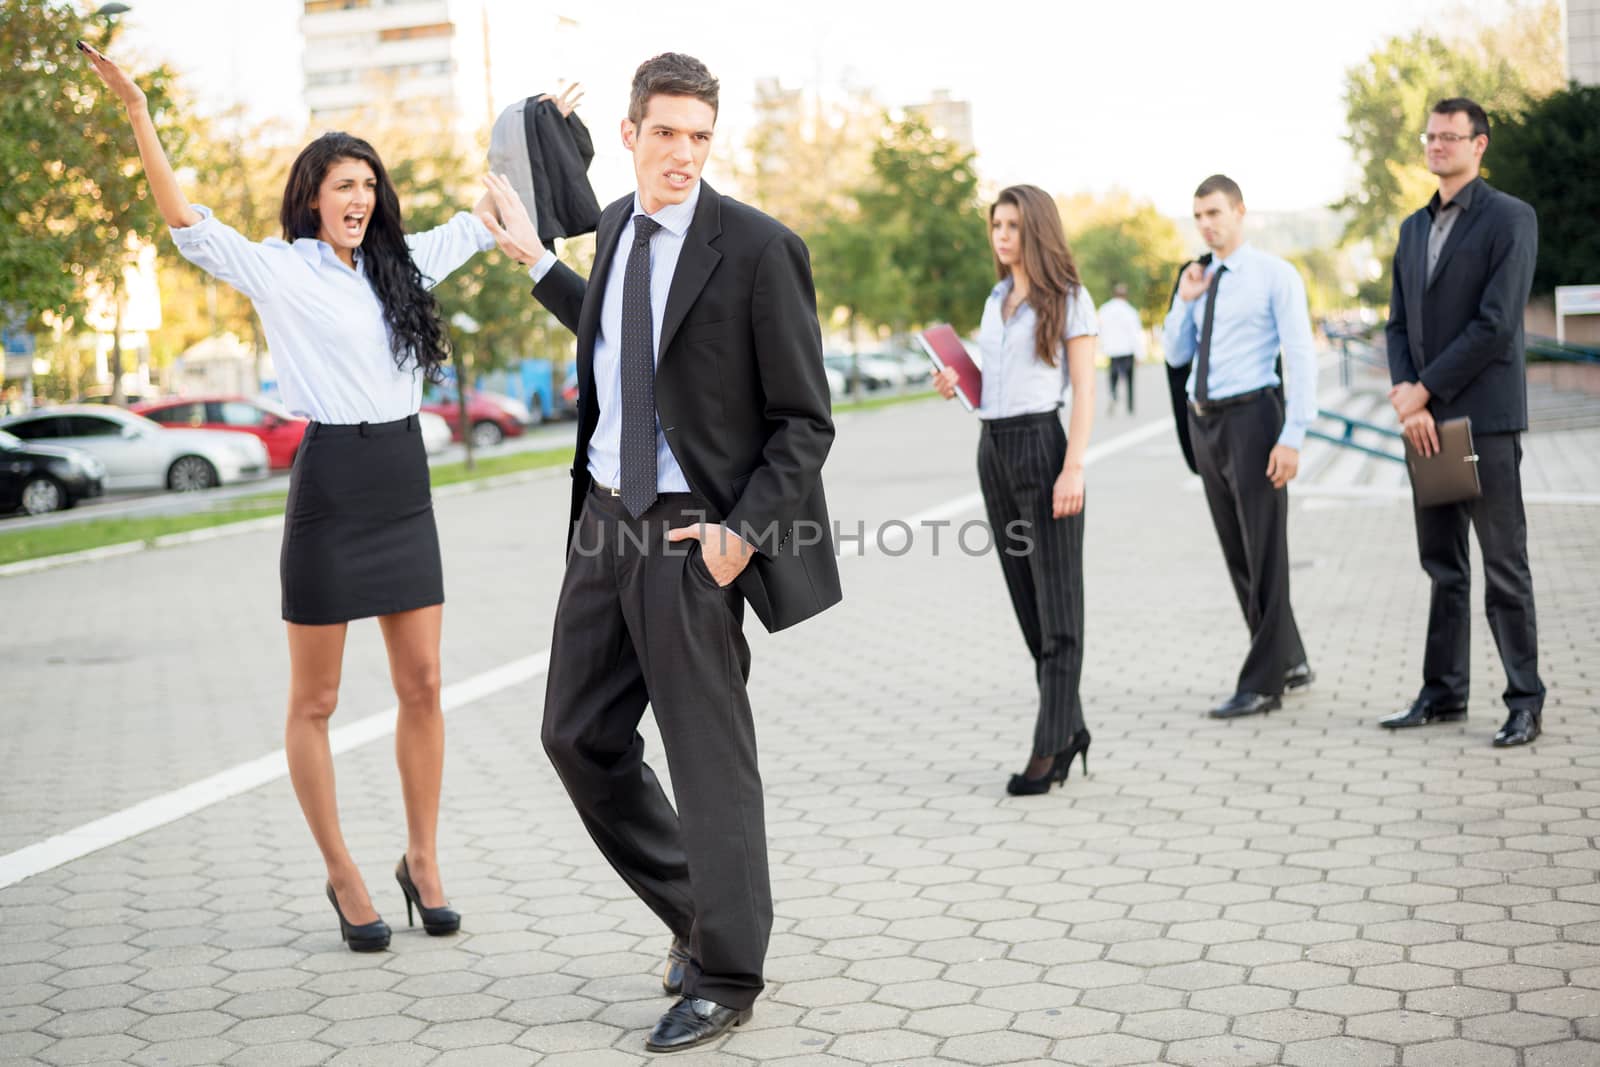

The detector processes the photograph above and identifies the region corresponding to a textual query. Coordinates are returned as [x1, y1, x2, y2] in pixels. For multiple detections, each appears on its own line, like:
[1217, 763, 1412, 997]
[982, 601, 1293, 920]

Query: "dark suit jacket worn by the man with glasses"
[1387, 178, 1539, 434]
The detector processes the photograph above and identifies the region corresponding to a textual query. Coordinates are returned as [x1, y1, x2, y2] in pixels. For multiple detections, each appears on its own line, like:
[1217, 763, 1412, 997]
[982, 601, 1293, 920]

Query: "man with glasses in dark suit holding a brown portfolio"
[1382, 98, 1544, 747]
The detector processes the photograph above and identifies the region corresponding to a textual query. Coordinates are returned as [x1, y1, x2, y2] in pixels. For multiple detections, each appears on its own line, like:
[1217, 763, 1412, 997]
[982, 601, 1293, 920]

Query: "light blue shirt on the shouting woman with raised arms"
[171, 205, 494, 426]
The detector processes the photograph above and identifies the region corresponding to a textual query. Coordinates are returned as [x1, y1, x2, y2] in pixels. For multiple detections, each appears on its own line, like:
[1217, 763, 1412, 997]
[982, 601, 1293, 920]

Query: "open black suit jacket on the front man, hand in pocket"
[533, 182, 842, 630]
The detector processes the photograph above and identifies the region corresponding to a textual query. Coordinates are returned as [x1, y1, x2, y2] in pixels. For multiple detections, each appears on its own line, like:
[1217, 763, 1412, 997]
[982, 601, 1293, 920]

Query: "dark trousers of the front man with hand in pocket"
[542, 493, 773, 1008]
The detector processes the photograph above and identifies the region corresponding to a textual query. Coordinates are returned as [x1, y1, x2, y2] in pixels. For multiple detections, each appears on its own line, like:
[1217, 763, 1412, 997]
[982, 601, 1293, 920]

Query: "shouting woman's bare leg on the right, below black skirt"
[378, 605, 446, 907]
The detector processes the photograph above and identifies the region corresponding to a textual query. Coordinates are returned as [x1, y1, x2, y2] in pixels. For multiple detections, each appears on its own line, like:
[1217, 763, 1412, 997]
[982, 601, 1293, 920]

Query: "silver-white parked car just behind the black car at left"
[0, 405, 267, 491]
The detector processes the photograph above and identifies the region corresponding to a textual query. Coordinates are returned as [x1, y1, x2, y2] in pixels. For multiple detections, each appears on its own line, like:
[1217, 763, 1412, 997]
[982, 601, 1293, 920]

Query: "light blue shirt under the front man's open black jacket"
[528, 182, 701, 493]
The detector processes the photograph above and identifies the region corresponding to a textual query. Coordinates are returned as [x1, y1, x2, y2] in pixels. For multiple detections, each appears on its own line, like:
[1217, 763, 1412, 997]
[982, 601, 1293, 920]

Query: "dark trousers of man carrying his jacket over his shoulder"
[1189, 389, 1306, 696]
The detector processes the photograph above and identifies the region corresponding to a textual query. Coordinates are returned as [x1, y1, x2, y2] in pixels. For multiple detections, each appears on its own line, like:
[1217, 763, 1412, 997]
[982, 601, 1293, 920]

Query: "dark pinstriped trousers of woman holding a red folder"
[978, 411, 1083, 757]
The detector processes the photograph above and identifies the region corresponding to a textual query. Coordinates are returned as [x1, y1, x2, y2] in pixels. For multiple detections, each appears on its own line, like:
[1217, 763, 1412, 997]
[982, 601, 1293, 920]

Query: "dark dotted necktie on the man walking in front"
[621, 214, 661, 518]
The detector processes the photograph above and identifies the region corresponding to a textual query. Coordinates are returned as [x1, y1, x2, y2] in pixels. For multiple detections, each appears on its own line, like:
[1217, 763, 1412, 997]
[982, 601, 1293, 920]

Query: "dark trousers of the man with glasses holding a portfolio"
[1416, 434, 1544, 712]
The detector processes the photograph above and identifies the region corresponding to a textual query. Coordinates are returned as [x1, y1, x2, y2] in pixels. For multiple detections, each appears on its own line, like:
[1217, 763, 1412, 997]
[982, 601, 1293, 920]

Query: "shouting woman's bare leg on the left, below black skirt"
[283, 622, 378, 926]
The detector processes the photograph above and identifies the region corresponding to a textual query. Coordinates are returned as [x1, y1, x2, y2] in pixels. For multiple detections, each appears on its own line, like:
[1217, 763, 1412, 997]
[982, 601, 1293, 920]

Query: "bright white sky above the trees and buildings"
[114, 0, 1529, 216]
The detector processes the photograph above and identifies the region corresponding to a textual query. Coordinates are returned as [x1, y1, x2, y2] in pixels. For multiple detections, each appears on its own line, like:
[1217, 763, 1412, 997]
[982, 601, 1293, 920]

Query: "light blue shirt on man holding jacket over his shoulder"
[1165, 245, 1317, 450]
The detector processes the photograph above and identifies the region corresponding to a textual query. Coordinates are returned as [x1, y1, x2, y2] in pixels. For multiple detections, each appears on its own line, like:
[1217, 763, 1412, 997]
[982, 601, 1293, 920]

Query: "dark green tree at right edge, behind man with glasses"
[1485, 83, 1600, 293]
